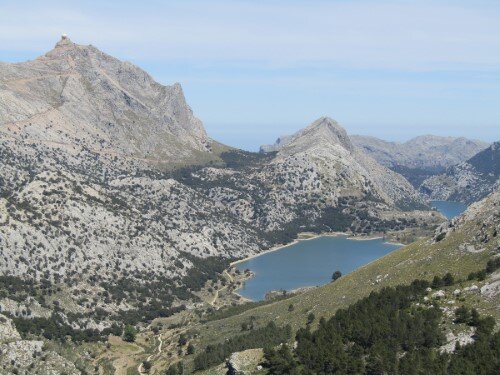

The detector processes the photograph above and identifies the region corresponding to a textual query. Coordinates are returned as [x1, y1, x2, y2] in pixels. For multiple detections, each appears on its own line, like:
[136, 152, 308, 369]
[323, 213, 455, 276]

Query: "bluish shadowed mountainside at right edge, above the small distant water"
[420, 142, 500, 203]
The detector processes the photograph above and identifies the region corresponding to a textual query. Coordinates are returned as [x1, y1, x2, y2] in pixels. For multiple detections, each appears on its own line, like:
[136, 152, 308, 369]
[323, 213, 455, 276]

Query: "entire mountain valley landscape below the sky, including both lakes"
[0, 36, 500, 375]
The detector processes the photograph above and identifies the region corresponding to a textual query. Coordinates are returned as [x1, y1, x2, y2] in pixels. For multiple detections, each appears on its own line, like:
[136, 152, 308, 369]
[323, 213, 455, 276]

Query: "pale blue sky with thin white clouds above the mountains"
[0, 0, 500, 150]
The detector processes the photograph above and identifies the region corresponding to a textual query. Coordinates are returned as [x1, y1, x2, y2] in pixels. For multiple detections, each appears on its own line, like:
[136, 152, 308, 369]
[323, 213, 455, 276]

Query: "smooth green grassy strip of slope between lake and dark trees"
[187, 222, 500, 372]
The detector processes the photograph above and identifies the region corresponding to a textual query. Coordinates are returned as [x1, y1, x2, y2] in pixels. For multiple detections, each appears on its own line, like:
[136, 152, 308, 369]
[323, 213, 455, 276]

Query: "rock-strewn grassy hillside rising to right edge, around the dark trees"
[183, 190, 500, 374]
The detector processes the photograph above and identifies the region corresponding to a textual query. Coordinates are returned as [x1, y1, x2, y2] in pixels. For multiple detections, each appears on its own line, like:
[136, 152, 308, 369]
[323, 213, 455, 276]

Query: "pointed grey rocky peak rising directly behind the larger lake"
[180, 117, 439, 238]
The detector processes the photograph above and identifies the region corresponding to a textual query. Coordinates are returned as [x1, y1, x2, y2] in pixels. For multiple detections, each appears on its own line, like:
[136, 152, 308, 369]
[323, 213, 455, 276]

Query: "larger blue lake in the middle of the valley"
[236, 236, 400, 301]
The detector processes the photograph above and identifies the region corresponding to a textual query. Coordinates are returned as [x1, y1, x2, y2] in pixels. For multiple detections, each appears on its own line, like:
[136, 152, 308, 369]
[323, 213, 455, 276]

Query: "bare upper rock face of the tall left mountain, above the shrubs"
[0, 38, 210, 163]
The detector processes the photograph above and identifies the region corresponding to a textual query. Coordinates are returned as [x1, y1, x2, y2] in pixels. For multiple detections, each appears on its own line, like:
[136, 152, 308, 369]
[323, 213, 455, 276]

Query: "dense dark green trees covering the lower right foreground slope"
[265, 275, 500, 375]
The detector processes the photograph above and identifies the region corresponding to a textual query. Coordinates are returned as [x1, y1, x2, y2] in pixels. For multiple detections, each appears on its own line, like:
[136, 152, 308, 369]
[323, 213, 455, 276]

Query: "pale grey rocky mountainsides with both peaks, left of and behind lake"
[0, 38, 443, 371]
